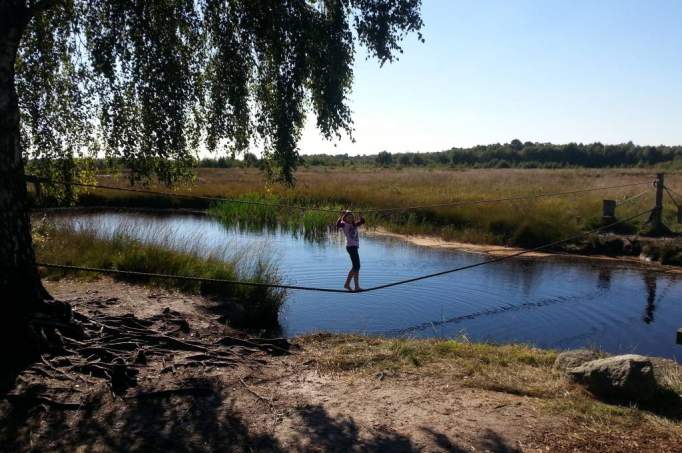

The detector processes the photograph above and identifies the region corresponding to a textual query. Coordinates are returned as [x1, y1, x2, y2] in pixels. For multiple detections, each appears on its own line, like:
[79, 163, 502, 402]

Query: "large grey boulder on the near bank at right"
[568, 354, 658, 402]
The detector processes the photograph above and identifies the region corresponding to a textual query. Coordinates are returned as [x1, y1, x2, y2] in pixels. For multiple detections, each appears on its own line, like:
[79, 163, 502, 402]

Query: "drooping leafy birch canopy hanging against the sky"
[15, 0, 422, 184]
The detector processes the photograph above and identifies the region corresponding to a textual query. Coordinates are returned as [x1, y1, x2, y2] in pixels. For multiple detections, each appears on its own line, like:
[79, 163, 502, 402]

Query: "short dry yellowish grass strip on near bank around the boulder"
[299, 334, 682, 451]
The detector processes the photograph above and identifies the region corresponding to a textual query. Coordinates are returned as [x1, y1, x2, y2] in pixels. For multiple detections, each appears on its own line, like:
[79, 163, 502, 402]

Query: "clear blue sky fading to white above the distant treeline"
[300, 0, 682, 154]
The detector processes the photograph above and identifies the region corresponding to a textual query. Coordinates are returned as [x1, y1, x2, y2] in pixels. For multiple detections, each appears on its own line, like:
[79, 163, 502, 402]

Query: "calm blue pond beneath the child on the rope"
[50, 212, 682, 361]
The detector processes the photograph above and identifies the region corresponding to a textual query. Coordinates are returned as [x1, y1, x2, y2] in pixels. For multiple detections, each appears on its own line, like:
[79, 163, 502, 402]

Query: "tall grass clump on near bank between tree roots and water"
[33, 217, 285, 328]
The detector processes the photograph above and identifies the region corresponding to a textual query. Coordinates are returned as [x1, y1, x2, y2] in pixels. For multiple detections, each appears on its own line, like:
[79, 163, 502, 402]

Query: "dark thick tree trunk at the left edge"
[0, 0, 68, 374]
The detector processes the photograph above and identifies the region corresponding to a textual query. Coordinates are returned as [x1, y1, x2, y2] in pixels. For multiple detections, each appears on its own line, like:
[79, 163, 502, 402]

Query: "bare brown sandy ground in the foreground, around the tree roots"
[0, 278, 673, 452]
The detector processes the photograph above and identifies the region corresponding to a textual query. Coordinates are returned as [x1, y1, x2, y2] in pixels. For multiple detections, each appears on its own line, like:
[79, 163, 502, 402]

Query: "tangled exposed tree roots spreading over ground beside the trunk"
[5, 308, 290, 410]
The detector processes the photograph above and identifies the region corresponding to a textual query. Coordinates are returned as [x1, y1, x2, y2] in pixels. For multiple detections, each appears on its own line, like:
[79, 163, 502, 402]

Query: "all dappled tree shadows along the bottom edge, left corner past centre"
[0, 378, 518, 453]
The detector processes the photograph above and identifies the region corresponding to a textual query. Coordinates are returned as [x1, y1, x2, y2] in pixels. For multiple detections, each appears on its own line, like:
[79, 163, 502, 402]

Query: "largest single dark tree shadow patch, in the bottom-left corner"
[0, 379, 281, 452]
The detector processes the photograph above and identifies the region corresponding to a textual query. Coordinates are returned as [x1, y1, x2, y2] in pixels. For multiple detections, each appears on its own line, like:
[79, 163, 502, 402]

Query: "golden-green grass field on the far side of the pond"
[51, 168, 682, 247]
